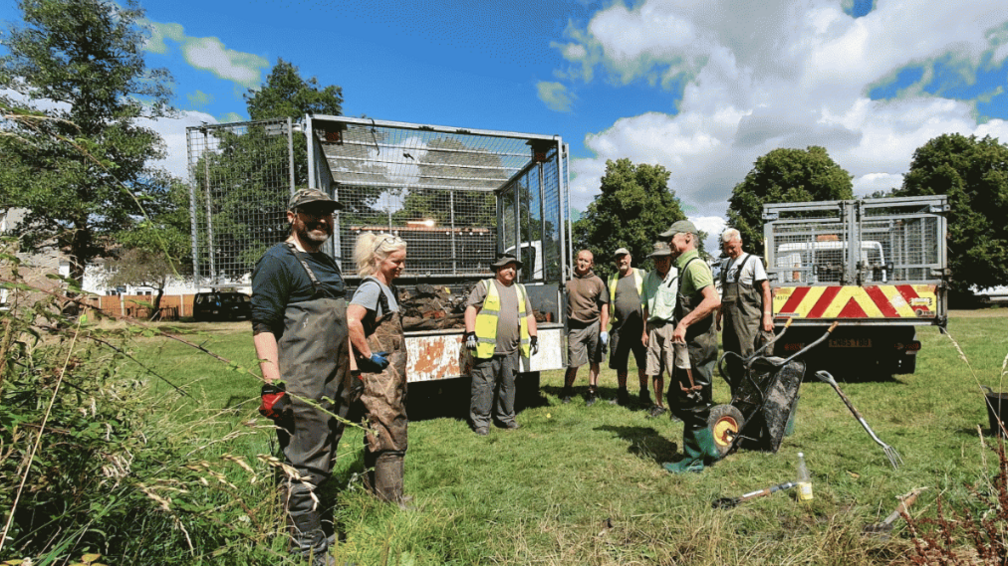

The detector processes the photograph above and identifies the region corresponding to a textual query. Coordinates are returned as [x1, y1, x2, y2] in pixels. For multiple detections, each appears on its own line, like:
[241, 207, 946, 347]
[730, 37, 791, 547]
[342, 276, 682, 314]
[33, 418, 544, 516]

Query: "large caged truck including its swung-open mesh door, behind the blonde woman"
[186, 115, 572, 391]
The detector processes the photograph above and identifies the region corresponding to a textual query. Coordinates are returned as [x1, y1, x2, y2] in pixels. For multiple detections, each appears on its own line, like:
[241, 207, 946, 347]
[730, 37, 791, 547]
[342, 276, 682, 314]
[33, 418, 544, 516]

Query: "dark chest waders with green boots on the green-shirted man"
[664, 258, 721, 473]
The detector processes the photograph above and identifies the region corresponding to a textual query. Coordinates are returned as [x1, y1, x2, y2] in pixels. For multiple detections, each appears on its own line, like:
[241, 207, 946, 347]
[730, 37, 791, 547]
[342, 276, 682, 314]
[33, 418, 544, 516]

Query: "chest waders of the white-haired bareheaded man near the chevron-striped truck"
[721, 254, 763, 396]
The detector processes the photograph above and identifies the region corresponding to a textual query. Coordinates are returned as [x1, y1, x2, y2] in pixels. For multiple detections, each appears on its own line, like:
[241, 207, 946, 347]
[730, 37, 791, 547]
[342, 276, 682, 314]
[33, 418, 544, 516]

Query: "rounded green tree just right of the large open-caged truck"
[574, 159, 685, 276]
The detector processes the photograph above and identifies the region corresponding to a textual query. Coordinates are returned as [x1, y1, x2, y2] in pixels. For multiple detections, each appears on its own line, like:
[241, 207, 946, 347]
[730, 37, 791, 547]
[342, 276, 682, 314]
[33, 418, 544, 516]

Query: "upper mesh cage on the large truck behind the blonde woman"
[312, 117, 566, 282]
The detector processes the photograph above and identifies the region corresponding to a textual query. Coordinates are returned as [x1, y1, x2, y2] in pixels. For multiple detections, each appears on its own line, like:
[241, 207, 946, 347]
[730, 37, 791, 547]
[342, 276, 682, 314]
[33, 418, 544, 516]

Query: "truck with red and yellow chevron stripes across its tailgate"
[763, 195, 950, 375]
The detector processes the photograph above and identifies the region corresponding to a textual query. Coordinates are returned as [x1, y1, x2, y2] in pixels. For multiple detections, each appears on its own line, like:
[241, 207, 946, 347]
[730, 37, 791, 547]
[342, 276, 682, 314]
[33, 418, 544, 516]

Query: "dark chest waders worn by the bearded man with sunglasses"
[277, 243, 351, 565]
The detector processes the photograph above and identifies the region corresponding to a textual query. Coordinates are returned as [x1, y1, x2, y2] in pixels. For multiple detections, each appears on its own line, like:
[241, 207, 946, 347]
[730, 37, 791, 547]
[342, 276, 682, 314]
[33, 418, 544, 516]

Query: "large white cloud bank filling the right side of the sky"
[554, 0, 1008, 218]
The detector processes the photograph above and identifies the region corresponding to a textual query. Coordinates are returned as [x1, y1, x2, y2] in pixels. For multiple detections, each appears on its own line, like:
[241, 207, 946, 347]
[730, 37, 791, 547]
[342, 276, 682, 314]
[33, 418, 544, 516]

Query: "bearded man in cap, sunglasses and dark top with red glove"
[252, 188, 352, 566]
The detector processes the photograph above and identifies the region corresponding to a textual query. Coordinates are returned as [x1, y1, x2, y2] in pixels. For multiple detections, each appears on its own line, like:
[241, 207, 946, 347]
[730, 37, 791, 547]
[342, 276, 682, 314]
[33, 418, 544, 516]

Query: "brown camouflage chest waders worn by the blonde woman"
[361, 278, 408, 504]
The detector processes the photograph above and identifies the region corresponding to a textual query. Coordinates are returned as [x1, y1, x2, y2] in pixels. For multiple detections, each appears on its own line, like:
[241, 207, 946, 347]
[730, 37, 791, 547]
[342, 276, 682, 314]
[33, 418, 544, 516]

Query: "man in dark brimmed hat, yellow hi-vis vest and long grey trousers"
[464, 254, 539, 436]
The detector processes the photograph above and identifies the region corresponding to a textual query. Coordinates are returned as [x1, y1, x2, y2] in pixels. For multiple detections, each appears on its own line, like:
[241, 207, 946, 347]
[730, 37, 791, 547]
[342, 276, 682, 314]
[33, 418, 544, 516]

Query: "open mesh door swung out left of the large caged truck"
[185, 119, 294, 287]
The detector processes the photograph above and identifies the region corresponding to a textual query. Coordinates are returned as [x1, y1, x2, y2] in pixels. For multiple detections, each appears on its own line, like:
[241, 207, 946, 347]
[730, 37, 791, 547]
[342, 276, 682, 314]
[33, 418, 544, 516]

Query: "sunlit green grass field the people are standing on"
[128, 309, 1008, 565]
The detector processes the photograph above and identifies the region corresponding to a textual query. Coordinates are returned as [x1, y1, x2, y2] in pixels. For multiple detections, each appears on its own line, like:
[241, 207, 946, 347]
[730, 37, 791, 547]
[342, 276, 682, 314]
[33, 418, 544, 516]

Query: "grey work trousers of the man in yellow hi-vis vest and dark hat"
[469, 350, 519, 428]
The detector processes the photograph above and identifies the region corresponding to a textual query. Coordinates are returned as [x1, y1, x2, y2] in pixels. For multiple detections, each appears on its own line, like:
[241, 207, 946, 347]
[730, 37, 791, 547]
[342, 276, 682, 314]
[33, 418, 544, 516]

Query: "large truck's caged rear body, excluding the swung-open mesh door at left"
[305, 116, 571, 390]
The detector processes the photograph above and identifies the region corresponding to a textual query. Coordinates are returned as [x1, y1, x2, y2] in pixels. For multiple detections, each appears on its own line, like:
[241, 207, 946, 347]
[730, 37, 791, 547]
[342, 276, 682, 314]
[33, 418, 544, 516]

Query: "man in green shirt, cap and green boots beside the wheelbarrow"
[660, 221, 721, 473]
